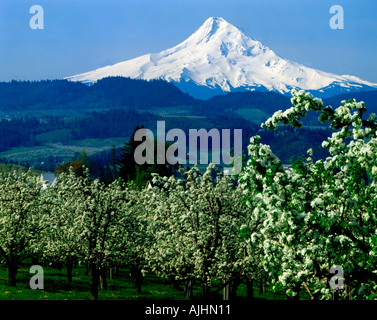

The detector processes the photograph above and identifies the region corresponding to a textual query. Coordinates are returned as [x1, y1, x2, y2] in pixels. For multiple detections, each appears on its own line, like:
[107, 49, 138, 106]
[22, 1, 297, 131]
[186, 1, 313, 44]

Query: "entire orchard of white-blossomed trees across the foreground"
[0, 90, 377, 300]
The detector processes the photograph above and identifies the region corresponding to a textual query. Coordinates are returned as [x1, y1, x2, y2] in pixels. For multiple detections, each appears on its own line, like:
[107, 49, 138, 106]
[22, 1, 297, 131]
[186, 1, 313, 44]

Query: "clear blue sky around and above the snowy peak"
[0, 0, 377, 83]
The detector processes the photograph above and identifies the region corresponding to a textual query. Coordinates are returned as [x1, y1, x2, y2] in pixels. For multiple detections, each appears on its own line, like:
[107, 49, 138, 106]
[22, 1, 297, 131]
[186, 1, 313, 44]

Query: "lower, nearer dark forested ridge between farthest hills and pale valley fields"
[0, 105, 328, 170]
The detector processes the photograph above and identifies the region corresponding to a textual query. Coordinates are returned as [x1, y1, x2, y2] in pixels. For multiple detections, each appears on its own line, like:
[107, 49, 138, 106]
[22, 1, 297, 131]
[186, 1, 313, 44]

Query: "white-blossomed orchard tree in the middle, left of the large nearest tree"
[148, 165, 247, 299]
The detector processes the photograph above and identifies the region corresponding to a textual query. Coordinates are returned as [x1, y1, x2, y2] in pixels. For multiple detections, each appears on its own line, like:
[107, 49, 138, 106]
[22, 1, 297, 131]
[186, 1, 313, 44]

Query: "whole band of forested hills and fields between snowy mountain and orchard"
[0, 77, 377, 175]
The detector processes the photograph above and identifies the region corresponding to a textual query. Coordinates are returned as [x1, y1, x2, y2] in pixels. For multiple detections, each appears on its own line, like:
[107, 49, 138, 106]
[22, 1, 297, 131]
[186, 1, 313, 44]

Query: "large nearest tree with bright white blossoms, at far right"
[240, 91, 377, 299]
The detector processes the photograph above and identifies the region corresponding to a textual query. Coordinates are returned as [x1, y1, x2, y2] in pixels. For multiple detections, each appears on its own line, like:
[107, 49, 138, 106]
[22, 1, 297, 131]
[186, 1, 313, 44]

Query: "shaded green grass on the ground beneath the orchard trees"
[0, 259, 294, 301]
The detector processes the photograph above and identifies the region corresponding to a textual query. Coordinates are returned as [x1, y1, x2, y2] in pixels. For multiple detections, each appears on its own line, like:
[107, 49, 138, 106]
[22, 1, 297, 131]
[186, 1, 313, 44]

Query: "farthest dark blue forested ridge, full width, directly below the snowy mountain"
[0, 77, 377, 116]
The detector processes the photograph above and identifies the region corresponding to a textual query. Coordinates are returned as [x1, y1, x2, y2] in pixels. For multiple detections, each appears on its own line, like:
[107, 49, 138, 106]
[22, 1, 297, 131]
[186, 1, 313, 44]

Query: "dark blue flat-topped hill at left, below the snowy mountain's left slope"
[0, 77, 197, 112]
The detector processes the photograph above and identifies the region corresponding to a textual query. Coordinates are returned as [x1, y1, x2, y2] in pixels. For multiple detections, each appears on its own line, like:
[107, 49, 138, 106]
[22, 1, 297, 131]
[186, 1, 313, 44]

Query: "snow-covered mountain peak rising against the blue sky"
[66, 17, 377, 97]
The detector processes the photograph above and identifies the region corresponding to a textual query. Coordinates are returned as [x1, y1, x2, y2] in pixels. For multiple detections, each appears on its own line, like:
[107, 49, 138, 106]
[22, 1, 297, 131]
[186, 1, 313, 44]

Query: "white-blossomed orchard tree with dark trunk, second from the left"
[43, 169, 125, 299]
